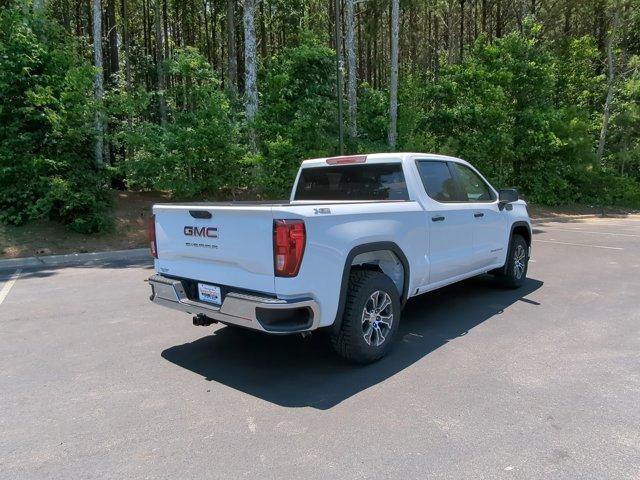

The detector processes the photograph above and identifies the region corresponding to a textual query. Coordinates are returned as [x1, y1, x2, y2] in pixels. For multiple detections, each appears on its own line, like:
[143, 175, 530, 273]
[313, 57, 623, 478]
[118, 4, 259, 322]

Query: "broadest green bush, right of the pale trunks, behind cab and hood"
[388, 22, 640, 206]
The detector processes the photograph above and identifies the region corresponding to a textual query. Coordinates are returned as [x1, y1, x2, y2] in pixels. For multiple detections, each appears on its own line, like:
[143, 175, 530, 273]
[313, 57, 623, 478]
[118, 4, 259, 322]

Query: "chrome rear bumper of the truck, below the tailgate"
[149, 275, 320, 334]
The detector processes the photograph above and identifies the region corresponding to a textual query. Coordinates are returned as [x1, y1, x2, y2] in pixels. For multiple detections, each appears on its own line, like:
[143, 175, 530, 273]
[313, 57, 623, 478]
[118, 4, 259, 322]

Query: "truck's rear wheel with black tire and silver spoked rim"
[331, 270, 400, 364]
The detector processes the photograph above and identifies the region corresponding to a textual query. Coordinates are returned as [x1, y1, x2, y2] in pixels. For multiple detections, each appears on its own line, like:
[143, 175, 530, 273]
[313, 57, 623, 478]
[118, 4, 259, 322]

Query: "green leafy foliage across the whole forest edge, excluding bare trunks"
[0, 0, 640, 232]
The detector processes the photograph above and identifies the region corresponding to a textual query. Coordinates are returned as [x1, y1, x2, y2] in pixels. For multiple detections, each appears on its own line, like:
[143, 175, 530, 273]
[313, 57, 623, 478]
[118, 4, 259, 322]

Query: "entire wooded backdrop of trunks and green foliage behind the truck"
[0, 0, 640, 233]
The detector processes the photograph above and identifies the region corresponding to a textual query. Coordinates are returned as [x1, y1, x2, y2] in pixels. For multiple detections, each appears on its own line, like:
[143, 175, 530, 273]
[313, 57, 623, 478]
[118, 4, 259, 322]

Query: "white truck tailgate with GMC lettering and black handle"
[153, 205, 274, 293]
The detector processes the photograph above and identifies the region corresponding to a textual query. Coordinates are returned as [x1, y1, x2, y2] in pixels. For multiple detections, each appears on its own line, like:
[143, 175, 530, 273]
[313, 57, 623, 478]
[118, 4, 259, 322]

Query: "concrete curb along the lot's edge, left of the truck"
[0, 248, 151, 270]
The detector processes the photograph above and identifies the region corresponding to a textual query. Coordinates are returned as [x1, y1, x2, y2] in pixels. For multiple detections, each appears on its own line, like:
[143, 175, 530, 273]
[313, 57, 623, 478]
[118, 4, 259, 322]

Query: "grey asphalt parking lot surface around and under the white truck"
[0, 216, 640, 479]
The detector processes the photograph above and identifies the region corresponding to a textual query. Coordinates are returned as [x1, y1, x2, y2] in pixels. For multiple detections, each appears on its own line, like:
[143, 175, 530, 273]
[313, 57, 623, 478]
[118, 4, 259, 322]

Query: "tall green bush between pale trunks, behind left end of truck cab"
[256, 36, 338, 191]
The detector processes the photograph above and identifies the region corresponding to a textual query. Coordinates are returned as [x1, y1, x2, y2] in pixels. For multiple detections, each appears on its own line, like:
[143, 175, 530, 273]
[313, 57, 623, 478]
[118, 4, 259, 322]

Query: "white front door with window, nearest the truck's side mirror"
[450, 162, 507, 270]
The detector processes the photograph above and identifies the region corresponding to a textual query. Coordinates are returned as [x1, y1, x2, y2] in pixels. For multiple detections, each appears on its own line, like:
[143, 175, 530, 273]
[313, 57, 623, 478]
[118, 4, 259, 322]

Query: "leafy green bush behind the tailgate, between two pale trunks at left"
[117, 48, 248, 197]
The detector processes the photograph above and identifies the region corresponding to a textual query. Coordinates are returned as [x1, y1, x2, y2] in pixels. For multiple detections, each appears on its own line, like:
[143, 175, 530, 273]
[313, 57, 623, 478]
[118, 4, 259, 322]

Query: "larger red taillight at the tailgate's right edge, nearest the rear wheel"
[273, 220, 307, 277]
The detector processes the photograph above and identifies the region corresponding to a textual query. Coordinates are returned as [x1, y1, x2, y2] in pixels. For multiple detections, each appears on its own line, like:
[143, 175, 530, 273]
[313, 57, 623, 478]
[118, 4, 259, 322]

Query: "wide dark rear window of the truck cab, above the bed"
[295, 163, 409, 200]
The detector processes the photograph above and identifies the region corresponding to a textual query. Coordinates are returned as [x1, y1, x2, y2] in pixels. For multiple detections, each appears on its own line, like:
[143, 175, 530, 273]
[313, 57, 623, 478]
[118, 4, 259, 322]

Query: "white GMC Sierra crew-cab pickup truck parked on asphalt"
[149, 153, 531, 363]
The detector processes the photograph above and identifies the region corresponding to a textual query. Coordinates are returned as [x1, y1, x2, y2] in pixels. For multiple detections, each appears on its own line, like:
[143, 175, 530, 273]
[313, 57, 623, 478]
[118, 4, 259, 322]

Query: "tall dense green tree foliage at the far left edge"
[0, 5, 110, 233]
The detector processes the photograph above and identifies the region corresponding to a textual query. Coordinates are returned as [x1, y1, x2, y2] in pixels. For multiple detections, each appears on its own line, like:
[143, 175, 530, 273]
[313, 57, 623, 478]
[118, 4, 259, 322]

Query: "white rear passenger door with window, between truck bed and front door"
[416, 160, 473, 285]
